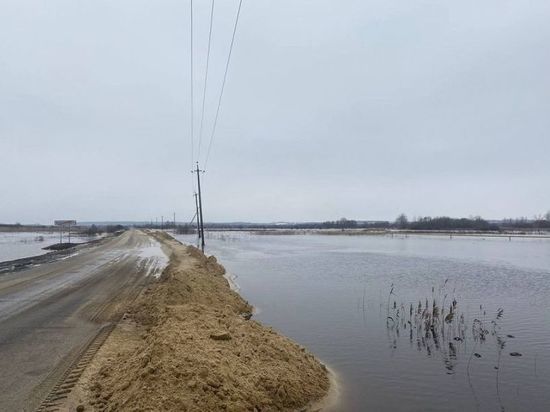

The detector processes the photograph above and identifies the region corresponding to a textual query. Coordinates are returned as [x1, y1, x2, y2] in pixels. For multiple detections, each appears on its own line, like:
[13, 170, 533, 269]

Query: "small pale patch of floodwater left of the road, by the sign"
[0, 232, 97, 262]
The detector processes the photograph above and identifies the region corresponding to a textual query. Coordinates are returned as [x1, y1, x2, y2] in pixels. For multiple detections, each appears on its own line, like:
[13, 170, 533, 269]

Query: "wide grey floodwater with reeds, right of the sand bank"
[178, 232, 550, 411]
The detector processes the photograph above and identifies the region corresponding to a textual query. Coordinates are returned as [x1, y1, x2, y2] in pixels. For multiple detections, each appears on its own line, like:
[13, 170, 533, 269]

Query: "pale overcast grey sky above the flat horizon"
[0, 0, 550, 223]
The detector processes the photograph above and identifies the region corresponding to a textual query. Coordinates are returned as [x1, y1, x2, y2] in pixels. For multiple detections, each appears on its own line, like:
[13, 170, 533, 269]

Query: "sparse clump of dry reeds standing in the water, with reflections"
[384, 279, 532, 411]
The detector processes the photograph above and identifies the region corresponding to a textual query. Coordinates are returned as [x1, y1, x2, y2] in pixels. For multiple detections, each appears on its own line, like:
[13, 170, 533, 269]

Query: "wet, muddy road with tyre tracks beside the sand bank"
[0, 231, 167, 411]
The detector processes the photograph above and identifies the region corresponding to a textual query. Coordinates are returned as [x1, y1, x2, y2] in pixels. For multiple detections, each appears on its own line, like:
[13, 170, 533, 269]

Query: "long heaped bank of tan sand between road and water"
[66, 234, 330, 411]
